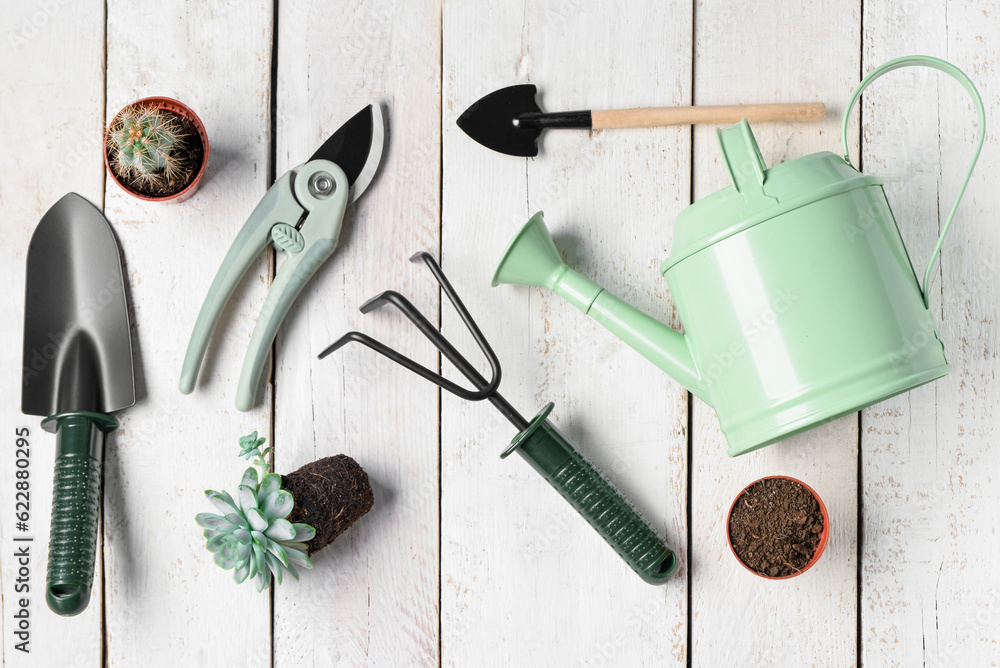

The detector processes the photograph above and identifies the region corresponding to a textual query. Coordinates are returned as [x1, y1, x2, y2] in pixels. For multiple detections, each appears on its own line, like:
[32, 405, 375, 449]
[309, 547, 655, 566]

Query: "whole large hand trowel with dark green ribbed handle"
[21, 193, 135, 616]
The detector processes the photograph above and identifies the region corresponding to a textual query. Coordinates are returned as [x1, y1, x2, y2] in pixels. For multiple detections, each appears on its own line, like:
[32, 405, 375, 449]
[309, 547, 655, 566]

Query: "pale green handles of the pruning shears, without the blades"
[180, 160, 350, 411]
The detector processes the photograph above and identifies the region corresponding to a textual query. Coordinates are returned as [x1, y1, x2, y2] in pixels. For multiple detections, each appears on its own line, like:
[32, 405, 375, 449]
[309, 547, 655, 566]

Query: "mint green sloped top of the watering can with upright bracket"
[660, 119, 882, 274]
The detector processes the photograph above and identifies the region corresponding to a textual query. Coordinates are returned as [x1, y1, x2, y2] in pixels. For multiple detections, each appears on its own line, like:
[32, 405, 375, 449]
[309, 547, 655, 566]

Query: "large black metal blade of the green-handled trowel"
[21, 193, 135, 416]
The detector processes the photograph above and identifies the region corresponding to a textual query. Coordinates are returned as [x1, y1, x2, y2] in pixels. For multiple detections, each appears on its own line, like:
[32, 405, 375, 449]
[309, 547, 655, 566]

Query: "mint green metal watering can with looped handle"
[493, 56, 986, 455]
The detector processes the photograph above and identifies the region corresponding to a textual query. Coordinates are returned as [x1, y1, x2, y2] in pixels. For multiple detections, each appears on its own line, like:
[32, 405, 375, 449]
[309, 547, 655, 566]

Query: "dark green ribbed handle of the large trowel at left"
[42, 412, 118, 617]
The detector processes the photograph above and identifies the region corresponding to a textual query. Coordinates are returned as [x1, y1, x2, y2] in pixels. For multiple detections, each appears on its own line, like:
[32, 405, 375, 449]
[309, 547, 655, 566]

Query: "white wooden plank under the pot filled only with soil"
[691, 0, 860, 666]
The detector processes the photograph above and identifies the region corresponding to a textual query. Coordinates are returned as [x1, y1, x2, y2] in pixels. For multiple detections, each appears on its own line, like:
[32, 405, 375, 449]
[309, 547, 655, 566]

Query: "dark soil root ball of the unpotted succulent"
[281, 455, 375, 556]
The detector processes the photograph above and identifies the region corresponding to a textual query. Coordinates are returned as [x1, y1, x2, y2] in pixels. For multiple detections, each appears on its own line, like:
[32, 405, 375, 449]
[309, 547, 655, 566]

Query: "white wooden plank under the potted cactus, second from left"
[104, 0, 272, 666]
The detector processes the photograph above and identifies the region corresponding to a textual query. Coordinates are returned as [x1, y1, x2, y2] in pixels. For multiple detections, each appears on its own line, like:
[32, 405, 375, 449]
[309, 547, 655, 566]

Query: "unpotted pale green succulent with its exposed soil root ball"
[195, 432, 375, 591]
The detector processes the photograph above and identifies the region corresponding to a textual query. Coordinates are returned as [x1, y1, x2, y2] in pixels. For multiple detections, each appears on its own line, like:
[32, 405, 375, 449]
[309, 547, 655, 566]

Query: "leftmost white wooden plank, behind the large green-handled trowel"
[0, 2, 106, 668]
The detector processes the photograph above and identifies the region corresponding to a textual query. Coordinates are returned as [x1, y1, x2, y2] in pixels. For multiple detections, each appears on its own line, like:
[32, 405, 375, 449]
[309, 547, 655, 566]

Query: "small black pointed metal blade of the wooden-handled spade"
[457, 84, 592, 158]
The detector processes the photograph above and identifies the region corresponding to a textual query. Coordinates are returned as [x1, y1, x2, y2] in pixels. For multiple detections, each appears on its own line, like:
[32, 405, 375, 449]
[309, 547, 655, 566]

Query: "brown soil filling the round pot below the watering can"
[729, 478, 823, 578]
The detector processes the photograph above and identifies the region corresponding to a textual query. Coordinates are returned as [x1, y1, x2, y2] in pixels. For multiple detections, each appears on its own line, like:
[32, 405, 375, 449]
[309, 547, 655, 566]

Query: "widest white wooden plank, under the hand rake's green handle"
[442, 1, 691, 666]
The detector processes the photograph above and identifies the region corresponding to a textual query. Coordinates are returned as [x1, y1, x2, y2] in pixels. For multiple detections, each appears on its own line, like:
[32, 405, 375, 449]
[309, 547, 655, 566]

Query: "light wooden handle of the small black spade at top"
[591, 102, 826, 130]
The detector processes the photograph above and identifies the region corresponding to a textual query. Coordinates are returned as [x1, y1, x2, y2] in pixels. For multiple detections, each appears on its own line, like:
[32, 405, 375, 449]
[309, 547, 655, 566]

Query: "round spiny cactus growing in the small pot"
[108, 105, 186, 186]
